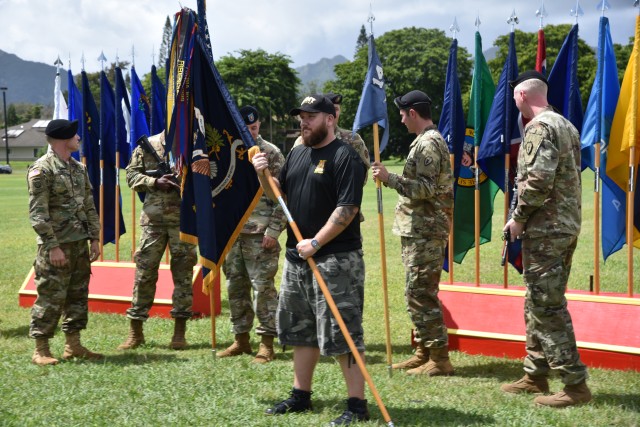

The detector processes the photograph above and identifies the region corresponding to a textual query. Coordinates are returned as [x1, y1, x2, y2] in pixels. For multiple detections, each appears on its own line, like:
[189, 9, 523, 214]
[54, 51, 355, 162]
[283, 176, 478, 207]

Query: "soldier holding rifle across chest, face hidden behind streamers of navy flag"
[118, 132, 197, 350]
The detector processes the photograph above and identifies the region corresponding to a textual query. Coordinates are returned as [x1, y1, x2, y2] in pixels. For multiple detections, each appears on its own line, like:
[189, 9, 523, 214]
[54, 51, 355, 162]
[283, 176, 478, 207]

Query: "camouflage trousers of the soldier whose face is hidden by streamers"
[127, 225, 197, 321]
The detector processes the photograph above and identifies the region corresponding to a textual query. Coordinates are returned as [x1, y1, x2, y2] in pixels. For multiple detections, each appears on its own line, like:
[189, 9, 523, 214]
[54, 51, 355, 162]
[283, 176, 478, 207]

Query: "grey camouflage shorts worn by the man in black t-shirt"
[276, 250, 364, 356]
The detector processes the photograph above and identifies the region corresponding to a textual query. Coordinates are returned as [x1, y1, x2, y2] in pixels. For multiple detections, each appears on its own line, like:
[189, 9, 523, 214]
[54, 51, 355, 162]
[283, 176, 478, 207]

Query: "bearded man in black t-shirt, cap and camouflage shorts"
[253, 95, 369, 425]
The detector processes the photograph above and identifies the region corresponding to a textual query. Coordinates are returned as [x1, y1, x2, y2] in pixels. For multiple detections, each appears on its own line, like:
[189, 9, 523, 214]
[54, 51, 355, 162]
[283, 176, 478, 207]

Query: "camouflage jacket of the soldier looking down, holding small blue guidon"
[385, 125, 453, 239]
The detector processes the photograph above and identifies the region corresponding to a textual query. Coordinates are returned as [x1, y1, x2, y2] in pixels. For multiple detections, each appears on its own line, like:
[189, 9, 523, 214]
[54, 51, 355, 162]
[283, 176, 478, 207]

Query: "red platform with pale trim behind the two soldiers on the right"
[439, 283, 640, 371]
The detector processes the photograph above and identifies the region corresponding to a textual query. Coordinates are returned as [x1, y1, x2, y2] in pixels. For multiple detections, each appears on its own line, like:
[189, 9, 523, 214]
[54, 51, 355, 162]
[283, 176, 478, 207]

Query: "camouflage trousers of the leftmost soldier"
[29, 240, 91, 338]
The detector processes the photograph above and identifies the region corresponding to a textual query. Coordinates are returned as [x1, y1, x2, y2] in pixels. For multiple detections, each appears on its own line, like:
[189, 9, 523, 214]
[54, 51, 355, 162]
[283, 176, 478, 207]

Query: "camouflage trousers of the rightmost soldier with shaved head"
[522, 236, 588, 384]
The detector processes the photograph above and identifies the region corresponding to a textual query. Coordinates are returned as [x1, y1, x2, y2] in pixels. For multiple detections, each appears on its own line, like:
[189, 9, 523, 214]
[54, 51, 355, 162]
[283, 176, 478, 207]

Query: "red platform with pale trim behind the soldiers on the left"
[18, 261, 221, 317]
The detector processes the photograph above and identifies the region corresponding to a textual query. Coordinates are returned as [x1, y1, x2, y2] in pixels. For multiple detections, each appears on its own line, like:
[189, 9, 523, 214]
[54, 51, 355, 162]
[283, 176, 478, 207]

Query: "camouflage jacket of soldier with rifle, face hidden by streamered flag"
[127, 133, 180, 226]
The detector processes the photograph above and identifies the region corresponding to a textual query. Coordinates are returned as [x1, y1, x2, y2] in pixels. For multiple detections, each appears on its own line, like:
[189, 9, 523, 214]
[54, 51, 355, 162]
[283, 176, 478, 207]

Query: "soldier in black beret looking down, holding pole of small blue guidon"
[373, 90, 453, 376]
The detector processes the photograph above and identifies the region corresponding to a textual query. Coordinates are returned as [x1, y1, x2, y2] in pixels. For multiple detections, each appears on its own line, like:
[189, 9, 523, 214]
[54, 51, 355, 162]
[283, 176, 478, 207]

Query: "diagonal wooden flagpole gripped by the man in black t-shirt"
[249, 146, 394, 427]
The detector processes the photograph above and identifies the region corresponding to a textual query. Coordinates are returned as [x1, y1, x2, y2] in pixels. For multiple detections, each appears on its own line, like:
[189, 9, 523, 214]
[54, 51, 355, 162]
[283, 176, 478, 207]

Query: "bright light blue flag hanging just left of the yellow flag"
[581, 16, 626, 260]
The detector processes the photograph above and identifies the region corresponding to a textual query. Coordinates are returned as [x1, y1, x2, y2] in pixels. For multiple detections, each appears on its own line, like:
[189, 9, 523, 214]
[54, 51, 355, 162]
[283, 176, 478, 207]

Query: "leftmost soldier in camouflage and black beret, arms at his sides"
[27, 120, 102, 365]
